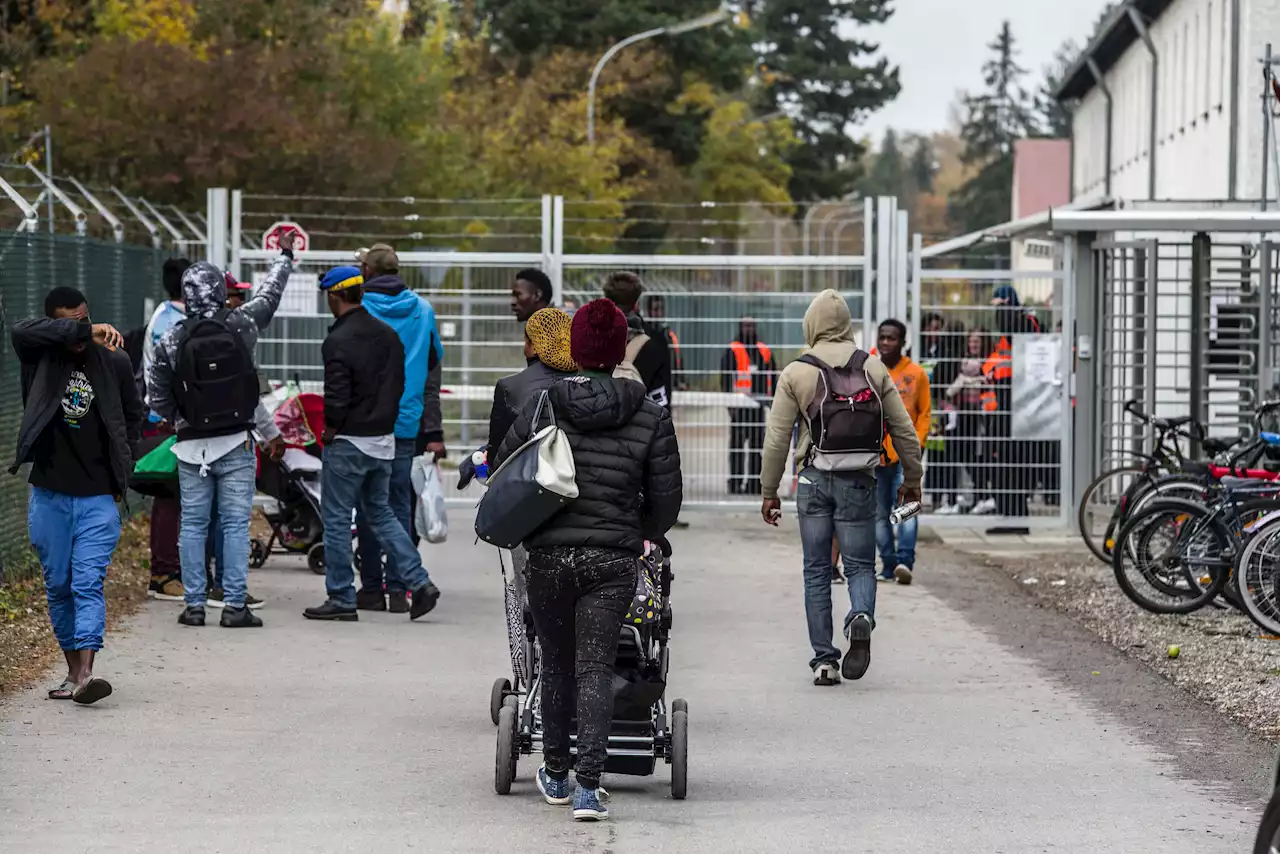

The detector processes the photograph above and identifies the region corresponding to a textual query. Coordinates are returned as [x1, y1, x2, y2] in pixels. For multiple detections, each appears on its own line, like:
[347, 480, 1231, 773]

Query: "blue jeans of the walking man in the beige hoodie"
[796, 466, 876, 667]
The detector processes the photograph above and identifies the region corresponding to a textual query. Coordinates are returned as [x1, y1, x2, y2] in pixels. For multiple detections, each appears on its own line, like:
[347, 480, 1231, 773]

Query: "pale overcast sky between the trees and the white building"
[855, 0, 1121, 140]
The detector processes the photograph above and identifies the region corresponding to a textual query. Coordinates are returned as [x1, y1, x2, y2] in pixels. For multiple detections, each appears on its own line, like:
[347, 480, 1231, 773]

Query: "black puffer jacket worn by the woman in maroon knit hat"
[489, 375, 684, 554]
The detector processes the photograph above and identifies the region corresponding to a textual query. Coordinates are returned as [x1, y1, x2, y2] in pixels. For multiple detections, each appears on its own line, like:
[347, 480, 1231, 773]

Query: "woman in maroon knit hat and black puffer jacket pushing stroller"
[489, 300, 682, 821]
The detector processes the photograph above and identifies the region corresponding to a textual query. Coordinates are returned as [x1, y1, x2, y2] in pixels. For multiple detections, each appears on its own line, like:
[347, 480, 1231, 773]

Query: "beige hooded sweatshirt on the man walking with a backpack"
[760, 289, 924, 498]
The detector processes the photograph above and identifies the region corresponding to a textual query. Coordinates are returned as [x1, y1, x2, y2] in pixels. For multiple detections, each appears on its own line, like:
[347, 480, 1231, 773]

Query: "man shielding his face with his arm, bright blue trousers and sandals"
[9, 287, 143, 704]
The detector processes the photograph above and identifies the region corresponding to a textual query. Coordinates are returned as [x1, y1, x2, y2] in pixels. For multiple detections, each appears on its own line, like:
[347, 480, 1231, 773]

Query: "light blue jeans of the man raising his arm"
[178, 440, 257, 608]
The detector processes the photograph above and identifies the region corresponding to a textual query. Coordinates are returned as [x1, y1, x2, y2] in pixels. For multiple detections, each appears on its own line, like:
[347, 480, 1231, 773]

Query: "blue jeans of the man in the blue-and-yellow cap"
[320, 439, 430, 608]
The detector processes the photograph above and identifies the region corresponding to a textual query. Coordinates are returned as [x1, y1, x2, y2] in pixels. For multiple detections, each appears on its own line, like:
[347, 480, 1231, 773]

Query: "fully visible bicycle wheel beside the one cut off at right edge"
[1111, 498, 1235, 613]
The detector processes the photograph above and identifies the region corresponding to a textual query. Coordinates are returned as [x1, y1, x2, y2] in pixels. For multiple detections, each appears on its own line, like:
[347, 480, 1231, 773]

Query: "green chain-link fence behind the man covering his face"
[0, 233, 165, 577]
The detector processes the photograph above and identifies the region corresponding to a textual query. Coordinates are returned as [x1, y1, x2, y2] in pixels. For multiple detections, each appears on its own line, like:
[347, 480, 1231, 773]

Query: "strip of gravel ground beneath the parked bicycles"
[986, 547, 1280, 743]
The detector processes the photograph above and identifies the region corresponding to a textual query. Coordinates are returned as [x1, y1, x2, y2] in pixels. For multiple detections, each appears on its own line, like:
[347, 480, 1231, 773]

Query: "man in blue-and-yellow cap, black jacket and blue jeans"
[303, 266, 440, 621]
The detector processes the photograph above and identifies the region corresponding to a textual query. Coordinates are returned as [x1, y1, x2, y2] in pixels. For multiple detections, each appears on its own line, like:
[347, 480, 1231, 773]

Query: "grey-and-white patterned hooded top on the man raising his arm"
[147, 255, 293, 466]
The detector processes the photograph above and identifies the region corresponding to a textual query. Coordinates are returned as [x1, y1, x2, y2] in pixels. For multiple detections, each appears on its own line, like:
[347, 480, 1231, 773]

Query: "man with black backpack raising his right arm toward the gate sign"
[147, 232, 294, 629]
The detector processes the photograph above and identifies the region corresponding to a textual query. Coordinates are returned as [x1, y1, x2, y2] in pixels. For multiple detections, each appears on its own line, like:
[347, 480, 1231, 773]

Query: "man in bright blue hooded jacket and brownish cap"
[356, 243, 445, 613]
